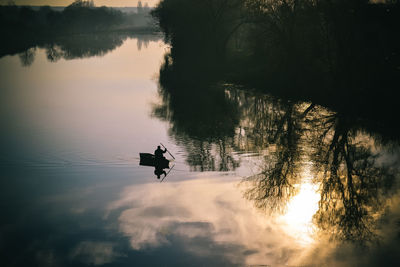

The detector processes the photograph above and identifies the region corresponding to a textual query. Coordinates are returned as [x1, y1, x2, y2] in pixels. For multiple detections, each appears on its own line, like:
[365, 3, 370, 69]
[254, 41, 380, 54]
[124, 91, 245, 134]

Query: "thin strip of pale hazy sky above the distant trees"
[4, 0, 159, 6]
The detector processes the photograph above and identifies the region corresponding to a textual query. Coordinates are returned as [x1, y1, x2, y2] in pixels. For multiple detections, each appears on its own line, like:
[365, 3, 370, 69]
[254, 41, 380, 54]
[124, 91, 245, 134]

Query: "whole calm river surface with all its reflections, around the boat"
[0, 36, 400, 266]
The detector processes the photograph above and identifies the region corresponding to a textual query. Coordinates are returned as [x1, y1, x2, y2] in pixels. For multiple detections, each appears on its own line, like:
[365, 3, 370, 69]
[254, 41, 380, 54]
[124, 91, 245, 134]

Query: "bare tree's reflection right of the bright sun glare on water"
[310, 110, 394, 242]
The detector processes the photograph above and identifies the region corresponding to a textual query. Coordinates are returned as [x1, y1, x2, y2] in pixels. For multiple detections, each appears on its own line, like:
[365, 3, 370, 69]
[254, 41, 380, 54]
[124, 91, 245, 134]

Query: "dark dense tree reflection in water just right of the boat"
[153, 55, 239, 171]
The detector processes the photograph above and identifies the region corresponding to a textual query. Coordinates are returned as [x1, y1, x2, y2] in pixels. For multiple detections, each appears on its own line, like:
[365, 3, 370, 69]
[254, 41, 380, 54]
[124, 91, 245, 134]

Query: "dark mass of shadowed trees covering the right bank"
[152, 0, 400, 134]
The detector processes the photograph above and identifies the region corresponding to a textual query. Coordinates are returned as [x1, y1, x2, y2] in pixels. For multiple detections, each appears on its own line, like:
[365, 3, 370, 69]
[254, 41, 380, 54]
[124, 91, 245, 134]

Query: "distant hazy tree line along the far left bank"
[0, 0, 155, 56]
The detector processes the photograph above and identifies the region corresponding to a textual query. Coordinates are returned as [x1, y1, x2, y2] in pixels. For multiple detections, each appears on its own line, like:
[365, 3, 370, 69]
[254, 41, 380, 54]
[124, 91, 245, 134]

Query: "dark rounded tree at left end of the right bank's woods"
[152, 0, 246, 62]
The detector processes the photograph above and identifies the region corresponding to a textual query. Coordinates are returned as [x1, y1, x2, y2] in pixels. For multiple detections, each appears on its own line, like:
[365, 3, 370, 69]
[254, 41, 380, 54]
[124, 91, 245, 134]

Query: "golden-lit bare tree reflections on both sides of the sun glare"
[238, 94, 394, 243]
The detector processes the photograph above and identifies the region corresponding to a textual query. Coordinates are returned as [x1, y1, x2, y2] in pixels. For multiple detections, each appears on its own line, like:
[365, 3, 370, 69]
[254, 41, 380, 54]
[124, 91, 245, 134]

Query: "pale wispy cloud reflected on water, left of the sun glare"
[107, 179, 304, 266]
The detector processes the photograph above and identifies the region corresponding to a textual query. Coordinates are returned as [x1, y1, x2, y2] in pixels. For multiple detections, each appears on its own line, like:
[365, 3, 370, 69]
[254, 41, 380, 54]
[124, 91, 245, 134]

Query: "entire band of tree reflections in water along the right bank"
[153, 55, 394, 244]
